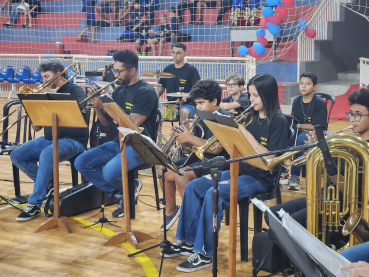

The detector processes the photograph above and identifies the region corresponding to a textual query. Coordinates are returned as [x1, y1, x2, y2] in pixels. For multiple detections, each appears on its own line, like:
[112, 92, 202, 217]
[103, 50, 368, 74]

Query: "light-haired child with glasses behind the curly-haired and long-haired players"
[219, 74, 250, 114]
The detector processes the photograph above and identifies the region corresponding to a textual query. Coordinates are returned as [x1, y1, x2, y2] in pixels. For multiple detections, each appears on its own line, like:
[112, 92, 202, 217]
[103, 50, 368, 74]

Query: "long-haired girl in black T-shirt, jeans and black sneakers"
[161, 73, 289, 272]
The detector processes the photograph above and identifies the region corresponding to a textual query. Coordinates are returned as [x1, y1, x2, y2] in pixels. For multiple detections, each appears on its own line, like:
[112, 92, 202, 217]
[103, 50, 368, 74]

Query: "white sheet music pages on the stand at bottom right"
[251, 198, 352, 277]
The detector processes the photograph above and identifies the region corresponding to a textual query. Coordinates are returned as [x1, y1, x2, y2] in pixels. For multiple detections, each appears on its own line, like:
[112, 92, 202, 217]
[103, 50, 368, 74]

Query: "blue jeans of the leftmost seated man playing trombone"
[10, 137, 85, 208]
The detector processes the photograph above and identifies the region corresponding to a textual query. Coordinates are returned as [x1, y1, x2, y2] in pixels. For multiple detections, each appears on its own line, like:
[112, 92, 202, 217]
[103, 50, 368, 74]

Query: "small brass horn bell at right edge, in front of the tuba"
[342, 209, 369, 243]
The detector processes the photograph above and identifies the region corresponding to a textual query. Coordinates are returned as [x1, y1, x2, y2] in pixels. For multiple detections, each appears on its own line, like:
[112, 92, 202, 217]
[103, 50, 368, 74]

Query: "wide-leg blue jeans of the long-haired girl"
[176, 171, 267, 257]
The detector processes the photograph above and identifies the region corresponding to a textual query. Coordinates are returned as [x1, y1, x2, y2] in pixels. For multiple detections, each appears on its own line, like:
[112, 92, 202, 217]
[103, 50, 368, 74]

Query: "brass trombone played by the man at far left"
[0, 62, 81, 136]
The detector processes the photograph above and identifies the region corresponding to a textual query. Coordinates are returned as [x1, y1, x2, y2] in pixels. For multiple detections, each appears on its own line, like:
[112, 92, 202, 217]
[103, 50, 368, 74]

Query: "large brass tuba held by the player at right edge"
[306, 133, 369, 252]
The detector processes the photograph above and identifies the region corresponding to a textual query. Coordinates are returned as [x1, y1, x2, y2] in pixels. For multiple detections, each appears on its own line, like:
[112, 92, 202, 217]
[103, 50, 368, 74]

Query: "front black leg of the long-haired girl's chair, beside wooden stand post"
[238, 200, 249, 262]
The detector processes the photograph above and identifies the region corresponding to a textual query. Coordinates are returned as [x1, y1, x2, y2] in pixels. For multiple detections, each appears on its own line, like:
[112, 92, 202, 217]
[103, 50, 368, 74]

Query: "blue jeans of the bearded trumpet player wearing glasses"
[74, 141, 144, 197]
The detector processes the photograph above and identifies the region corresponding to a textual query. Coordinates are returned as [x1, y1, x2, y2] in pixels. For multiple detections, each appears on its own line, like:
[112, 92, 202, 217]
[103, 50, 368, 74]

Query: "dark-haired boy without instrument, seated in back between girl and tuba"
[288, 73, 328, 190]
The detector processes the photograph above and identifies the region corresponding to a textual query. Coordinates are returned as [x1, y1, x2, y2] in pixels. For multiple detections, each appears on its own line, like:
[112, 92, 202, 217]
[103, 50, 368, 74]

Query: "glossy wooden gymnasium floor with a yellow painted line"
[0, 98, 349, 277]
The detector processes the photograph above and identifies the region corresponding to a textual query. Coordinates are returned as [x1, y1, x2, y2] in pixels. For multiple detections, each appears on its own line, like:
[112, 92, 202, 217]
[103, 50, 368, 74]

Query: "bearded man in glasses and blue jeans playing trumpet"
[75, 49, 158, 217]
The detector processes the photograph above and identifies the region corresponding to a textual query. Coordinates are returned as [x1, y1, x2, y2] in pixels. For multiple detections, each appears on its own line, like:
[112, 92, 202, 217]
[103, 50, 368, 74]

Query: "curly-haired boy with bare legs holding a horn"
[159, 80, 228, 231]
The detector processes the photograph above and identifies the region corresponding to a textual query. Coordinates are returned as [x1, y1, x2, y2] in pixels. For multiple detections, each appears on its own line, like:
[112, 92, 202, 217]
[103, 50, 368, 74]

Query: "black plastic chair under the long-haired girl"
[224, 166, 282, 262]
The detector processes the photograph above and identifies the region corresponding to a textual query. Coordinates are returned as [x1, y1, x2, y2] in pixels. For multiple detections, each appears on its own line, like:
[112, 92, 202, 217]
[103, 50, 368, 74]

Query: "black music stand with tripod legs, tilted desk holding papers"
[124, 133, 184, 276]
